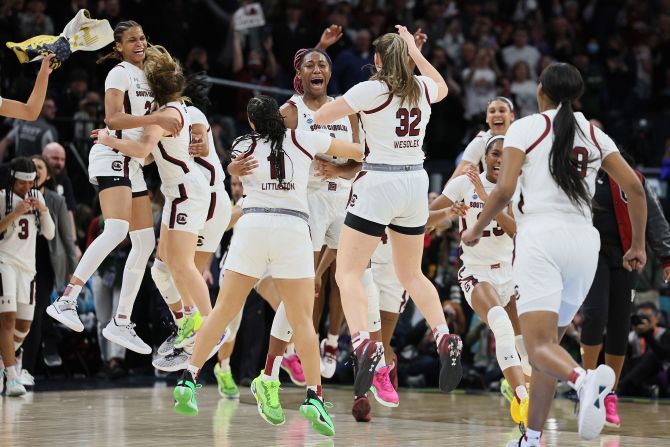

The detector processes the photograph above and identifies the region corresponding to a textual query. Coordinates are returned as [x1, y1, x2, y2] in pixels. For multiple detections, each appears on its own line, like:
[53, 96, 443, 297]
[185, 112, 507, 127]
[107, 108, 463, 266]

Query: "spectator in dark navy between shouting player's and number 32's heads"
[330, 29, 374, 93]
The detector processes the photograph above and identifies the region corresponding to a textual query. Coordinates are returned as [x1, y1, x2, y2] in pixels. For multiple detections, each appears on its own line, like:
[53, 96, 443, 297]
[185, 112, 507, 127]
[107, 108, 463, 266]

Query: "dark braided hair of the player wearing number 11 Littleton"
[232, 95, 290, 184]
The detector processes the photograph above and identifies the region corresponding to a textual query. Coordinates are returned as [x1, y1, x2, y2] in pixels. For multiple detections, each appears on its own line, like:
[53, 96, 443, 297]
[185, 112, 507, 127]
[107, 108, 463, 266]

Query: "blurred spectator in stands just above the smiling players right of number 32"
[463, 48, 497, 122]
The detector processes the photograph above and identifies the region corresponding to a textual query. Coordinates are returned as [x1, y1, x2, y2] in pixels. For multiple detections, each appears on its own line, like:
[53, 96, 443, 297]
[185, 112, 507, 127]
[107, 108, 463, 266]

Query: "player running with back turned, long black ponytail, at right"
[462, 63, 647, 446]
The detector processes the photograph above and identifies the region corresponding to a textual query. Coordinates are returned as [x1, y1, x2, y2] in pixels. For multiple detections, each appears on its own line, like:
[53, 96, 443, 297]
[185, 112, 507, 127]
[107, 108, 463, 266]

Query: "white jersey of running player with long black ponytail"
[504, 109, 618, 225]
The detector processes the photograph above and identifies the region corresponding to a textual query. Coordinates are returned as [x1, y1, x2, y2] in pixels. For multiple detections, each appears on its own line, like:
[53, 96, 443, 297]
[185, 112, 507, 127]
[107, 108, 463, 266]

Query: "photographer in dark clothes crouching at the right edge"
[619, 302, 670, 397]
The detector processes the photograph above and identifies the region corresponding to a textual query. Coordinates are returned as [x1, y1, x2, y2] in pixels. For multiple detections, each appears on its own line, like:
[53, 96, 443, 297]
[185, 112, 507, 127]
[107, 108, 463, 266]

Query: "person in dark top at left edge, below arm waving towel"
[0, 96, 58, 157]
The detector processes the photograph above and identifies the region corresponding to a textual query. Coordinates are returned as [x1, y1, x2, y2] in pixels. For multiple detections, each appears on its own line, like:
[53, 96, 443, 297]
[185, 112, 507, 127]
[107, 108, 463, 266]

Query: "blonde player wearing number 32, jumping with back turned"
[314, 25, 462, 396]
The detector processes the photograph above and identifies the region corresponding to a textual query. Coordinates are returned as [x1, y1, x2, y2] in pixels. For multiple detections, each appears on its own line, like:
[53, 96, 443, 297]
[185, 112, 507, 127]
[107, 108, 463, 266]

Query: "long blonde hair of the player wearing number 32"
[370, 33, 421, 107]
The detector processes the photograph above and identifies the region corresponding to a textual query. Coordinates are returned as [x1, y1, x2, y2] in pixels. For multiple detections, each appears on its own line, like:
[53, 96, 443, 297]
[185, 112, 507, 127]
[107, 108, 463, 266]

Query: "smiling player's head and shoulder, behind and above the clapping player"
[449, 96, 514, 181]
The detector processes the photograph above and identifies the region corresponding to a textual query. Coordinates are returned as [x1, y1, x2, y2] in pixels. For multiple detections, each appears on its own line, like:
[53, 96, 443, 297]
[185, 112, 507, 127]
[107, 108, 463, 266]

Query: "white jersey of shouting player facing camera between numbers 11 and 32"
[287, 95, 353, 191]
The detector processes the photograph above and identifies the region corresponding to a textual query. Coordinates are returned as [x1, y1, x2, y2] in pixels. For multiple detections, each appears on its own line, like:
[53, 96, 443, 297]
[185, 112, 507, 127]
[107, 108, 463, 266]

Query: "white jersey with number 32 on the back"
[343, 76, 437, 165]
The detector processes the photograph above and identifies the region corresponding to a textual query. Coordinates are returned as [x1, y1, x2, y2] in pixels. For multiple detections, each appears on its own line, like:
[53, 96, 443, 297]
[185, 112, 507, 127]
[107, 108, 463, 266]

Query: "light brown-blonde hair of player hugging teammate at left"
[144, 45, 188, 105]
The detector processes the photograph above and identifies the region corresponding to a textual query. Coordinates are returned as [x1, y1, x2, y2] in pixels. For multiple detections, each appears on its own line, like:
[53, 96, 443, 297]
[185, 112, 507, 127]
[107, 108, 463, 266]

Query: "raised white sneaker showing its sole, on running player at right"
[577, 365, 615, 440]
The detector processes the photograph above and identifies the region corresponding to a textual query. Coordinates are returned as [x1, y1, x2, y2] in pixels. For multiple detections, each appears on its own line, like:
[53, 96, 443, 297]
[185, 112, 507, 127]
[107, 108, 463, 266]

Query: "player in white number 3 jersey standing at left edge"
[0, 158, 56, 396]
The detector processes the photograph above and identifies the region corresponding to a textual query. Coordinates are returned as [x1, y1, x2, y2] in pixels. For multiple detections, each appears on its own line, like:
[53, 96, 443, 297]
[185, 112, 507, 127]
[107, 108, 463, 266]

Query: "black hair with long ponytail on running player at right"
[540, 63, 591, 211]
